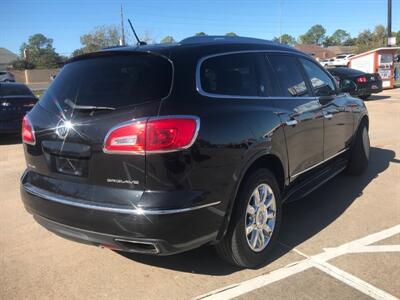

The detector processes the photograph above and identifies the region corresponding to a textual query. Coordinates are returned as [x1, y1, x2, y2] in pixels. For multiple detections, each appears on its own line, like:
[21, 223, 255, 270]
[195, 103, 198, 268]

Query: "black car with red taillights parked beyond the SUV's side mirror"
[328, 67, 382, 100]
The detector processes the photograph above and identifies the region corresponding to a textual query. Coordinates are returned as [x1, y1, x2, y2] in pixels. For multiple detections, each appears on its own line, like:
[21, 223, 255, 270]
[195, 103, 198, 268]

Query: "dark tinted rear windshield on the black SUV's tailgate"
[40, 53, 172, 110]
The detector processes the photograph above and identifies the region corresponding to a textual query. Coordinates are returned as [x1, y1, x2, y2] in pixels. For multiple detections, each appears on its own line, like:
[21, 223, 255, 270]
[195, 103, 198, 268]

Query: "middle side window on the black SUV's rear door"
[270, 55, 310, 97]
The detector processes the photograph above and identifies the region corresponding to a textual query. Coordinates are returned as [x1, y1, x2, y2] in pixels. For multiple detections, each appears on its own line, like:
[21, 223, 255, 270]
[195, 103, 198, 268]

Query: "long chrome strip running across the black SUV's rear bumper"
[22, 183, 221, 215]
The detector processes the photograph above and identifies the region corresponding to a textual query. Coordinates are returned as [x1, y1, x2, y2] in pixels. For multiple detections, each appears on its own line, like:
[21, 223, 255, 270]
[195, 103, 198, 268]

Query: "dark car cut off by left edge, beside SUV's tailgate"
[0, 82, 38, 134]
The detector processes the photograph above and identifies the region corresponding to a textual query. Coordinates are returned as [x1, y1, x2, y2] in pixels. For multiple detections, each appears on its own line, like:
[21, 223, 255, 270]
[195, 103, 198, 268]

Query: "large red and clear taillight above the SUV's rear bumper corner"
[104, 116, 200, 154]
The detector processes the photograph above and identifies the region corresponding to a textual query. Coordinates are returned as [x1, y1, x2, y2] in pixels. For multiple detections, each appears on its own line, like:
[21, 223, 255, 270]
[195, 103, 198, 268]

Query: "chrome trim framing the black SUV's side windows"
[196, 50, 316, 100]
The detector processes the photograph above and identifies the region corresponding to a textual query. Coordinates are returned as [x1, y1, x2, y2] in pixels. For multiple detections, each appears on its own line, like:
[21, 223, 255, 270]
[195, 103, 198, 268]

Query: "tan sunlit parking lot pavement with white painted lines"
[0, 89, 400, 299]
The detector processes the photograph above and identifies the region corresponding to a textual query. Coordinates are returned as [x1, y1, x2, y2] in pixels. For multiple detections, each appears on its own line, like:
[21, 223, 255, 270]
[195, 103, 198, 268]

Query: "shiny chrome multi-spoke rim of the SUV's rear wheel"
[245, 183, 276, 252]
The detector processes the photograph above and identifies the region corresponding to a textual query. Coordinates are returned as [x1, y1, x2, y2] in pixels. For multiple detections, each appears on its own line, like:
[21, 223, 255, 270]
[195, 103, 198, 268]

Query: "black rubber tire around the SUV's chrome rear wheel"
[216, 169, 282, 268]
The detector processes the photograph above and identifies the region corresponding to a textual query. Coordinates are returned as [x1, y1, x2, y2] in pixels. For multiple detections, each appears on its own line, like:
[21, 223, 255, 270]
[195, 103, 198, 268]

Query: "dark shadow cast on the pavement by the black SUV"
[120, 147, 399, 276]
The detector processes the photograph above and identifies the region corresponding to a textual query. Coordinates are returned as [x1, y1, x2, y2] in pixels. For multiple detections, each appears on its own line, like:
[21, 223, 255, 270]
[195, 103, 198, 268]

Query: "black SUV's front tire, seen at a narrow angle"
[347, 122, 370, 175]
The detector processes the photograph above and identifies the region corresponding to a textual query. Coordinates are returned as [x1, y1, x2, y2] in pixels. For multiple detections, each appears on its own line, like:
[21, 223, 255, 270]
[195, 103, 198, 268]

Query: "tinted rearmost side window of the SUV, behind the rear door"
[200, 53, 270, 97]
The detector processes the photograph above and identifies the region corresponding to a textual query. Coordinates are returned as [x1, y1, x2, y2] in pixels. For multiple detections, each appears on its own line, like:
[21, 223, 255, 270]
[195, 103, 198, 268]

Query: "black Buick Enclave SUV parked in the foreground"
[21, 37, 369, 268]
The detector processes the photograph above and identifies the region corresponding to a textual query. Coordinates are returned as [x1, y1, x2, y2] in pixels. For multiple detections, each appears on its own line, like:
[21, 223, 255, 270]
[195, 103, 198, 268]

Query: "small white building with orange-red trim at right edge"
[349, 47, 400, 89]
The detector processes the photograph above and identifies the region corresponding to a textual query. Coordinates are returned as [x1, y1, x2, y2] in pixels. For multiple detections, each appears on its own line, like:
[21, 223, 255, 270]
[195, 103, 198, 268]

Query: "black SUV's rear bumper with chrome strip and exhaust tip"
[20, 170, 224, 255]
